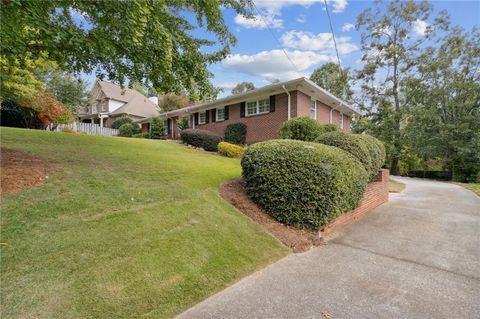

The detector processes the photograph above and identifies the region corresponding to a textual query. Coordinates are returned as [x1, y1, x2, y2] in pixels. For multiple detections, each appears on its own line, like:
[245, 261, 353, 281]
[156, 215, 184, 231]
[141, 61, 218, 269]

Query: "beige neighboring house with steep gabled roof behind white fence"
[78, 80, 160, 127]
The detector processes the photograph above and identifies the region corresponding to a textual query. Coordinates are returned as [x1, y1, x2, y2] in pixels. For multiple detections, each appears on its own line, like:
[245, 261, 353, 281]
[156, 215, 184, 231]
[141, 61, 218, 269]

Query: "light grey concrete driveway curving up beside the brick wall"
[180, 178, 480, 319]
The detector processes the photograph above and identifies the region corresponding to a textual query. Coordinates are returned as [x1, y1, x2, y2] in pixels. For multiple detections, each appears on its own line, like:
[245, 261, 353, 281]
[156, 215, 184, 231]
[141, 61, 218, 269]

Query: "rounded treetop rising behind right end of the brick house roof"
[310, 62, 353, 101]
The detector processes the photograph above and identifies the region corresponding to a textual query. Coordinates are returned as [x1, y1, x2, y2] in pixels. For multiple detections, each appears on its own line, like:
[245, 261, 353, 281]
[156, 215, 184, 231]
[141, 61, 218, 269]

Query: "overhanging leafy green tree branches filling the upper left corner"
[0, 0, 246, 98]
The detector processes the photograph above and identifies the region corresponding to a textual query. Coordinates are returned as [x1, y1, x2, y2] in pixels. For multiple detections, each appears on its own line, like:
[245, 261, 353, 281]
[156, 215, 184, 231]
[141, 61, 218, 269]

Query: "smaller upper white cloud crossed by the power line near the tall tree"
[281, 30, 358, 54]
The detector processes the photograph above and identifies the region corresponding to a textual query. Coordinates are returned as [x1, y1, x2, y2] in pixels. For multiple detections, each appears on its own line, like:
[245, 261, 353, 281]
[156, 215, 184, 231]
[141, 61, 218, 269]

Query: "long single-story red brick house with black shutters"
[138, 78, 359, 144]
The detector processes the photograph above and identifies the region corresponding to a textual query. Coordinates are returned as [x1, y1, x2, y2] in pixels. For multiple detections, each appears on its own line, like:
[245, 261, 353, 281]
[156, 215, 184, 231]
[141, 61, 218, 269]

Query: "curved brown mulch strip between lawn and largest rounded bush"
[220, 178, 323, 252]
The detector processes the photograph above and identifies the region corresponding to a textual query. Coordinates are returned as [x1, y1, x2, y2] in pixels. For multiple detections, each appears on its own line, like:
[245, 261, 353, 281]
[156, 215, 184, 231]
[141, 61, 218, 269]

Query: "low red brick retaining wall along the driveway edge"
[321, 169, 389, 236]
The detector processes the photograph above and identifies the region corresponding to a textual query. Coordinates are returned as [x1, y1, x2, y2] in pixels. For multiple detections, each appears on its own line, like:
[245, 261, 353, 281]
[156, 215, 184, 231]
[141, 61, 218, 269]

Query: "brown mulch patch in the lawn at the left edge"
[0, 148, 50, 196]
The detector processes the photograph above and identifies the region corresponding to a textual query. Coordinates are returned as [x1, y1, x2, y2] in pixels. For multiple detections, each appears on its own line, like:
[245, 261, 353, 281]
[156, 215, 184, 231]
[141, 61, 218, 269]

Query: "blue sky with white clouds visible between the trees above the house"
[80, 0, 480, 96]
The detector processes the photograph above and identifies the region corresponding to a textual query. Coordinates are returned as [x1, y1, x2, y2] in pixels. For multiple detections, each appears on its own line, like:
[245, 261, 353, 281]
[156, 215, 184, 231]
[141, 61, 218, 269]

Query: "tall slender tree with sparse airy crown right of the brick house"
[356, 0, 448, 174]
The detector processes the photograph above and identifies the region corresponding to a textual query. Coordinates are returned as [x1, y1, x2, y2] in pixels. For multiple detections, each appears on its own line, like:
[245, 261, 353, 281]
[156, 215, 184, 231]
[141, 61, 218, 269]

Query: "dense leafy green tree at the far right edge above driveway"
[405, 28, 480, 182]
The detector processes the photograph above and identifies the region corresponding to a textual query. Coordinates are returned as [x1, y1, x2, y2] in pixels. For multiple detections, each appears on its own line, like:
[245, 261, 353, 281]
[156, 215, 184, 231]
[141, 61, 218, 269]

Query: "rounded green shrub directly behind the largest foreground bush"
[315, 131, 376, 175]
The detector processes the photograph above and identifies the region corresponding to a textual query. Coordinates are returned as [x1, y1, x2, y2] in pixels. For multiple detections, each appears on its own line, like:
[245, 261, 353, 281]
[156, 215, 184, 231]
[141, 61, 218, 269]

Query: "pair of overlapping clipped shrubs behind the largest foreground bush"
[315, 131, 385, 179]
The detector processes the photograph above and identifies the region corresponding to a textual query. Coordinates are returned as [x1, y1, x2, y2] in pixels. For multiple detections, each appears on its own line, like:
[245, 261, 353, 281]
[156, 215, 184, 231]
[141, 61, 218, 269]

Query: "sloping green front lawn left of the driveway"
[0, 128, 288, 318]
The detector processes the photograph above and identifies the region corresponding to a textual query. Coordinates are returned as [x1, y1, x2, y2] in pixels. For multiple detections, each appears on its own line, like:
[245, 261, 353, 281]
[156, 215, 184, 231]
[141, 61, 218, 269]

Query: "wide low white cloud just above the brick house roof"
[222, 49, 334, 80]
